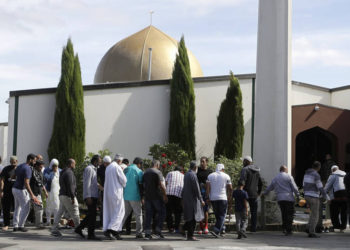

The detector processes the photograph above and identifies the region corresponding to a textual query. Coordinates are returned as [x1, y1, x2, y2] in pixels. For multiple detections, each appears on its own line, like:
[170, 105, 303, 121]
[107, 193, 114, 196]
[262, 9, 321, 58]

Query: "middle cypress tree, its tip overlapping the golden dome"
[169, 36, 196, 159]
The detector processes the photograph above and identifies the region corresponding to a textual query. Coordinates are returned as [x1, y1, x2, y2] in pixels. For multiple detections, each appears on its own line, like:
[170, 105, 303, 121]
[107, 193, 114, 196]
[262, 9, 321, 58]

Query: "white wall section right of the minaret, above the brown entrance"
[292, 84, 332, 105]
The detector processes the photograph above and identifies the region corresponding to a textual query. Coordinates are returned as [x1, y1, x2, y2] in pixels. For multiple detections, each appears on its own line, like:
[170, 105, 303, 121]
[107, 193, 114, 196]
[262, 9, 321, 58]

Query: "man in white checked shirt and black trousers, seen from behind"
[165, 166, 184, 233]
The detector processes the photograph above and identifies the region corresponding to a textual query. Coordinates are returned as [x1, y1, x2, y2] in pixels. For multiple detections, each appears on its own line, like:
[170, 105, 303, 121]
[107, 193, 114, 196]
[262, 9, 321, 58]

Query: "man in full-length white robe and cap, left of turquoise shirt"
[103, 155, 126, 240]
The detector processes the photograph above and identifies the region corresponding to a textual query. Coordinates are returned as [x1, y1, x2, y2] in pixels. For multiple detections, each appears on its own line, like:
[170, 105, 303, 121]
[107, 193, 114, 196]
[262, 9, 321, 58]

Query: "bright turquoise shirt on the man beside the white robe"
[124, 164, 143, 201]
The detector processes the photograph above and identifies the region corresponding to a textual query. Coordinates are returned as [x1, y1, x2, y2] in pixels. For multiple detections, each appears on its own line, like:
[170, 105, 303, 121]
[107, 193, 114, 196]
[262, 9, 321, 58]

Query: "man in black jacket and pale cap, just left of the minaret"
[240, 156, 263, 232]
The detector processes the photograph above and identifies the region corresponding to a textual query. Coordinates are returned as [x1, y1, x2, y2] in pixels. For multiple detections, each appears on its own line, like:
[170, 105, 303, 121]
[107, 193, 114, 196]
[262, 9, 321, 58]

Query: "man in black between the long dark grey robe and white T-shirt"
[197, 156, 213, 234]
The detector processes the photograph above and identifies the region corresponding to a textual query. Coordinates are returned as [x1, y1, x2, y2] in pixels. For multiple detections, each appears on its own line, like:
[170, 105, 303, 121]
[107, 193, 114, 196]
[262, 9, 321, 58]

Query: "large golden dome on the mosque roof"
[94, 26, 203, 83]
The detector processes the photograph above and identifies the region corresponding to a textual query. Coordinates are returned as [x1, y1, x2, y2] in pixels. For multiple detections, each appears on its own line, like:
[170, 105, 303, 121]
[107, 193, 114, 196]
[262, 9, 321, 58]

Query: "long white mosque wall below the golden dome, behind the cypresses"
[7, 79, 252, 163]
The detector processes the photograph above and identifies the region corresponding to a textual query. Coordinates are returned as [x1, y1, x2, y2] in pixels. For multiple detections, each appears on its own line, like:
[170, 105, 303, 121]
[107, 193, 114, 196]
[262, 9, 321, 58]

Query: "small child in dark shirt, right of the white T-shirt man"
[232, 181, 248, 239]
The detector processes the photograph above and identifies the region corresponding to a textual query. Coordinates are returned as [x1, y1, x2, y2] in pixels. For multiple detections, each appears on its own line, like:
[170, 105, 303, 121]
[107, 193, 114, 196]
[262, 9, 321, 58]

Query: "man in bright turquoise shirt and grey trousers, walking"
[122, 157, 143, 238]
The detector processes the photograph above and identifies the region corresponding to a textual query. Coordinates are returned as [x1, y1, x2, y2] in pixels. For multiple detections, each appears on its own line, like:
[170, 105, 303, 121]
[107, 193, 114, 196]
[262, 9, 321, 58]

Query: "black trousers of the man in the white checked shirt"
[166, 195, 182, 230]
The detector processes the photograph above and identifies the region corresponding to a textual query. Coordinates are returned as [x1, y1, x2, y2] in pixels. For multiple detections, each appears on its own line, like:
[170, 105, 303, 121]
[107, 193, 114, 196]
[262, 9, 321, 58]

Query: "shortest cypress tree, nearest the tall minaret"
[214, 71, 244, 159]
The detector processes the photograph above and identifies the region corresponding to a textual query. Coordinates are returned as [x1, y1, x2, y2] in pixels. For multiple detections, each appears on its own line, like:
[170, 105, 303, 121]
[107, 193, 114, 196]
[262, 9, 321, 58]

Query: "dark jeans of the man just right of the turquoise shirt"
[145, 200, 165, 234]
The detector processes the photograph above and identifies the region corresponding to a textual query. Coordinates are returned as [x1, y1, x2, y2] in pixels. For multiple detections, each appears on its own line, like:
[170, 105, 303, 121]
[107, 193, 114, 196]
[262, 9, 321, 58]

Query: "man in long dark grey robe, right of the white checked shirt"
[182, 161, 205, 241]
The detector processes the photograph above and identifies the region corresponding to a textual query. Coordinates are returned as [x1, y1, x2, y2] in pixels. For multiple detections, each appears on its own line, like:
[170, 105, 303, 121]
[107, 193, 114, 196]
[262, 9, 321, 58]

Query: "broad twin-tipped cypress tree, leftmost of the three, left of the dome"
[48, 39, 85, 165]
